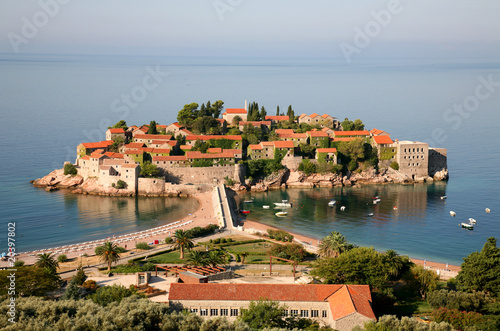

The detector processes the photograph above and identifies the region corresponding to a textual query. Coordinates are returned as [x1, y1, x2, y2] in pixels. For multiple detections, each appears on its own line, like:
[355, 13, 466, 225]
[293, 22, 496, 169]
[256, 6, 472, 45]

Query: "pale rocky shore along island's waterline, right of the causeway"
[233, 168, 448, 192]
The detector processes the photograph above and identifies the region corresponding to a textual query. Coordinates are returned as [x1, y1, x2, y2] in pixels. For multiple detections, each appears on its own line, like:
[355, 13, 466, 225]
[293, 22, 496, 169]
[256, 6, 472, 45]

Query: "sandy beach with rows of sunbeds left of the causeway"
[0, 191, 218, 268]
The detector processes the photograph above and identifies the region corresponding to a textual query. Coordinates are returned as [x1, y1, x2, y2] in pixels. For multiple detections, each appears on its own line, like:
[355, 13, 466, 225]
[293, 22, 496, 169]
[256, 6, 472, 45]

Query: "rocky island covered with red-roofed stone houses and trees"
[33, 100, 448, 196]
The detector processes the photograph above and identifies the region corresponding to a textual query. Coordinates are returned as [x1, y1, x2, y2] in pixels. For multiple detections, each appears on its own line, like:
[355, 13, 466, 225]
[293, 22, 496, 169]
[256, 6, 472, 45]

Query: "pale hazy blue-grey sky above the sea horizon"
[0, 0, 500, 58]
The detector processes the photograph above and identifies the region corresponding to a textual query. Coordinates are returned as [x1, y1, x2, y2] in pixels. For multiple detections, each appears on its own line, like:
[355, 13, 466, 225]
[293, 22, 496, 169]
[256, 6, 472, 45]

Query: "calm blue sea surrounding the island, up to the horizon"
[0, 54, 500, 264]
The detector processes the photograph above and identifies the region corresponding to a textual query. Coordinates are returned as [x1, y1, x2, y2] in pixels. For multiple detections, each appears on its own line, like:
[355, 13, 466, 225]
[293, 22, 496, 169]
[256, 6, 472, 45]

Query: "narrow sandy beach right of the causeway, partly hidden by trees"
[243, 220, 460, 280]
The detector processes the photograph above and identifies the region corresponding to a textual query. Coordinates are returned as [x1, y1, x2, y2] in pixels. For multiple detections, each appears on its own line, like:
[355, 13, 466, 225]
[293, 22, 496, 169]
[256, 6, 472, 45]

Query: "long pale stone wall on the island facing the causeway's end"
[165, 165, 244, 184]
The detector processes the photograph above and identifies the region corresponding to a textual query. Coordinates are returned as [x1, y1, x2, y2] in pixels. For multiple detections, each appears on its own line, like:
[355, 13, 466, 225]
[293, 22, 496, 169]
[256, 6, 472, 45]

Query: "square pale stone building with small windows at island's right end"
[394, 140, 429, 179]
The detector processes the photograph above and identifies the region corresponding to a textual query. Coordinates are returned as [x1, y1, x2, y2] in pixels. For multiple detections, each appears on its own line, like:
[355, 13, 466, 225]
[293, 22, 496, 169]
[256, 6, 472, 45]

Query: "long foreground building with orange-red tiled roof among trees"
[168, 283, 376, 331]
